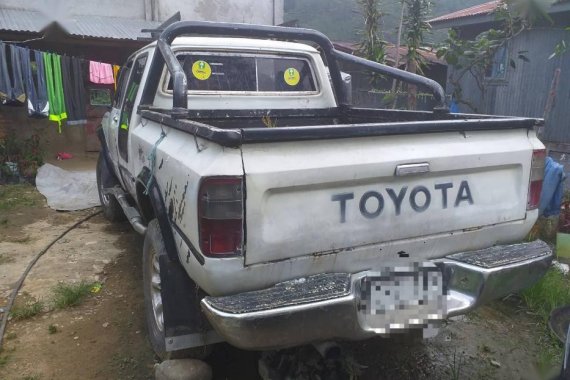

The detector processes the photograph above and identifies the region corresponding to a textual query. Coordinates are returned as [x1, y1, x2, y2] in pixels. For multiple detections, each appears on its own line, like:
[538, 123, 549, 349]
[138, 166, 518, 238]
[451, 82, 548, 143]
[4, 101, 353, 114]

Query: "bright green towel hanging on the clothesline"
[43, 53, 67, 133]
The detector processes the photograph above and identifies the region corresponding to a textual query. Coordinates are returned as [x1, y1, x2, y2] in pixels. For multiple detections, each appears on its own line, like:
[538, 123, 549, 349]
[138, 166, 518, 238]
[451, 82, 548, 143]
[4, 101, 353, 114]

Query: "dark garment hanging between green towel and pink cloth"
[61, 56, 87, 125]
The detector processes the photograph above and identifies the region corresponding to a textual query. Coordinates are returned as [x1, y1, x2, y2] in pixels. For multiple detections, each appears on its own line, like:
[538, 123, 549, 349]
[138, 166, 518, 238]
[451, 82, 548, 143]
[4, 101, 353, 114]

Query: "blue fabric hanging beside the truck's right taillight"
[539, 157, 566, 216]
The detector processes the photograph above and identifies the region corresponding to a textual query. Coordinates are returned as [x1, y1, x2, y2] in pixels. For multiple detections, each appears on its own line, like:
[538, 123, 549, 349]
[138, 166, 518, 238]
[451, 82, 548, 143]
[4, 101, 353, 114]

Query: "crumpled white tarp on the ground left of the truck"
[36, 164, 100, 211]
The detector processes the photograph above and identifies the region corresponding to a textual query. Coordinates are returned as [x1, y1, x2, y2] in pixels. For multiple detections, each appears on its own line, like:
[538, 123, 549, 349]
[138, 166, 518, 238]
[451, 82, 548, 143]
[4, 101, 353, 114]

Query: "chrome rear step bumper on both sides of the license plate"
[202, 241, 552, 349]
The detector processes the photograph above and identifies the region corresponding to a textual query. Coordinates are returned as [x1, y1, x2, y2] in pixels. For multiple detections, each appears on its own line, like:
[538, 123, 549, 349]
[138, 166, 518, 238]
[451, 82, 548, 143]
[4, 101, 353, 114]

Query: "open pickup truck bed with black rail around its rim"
[141, 107, 540, 147]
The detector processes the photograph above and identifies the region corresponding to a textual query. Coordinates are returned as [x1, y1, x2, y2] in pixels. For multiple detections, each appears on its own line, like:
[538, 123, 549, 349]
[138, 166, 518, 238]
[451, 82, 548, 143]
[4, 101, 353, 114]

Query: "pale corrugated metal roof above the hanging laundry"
[0, 8, 160, 40]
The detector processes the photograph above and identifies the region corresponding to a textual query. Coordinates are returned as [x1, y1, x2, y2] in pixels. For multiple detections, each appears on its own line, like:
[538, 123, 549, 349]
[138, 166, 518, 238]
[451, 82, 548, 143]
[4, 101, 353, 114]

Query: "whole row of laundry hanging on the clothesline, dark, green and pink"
[0, 41, 119, 133]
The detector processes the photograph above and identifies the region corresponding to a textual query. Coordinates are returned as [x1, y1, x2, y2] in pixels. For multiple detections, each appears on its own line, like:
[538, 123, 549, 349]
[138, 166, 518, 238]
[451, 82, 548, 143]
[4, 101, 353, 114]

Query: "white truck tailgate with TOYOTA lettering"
[242, 129, 532, 265]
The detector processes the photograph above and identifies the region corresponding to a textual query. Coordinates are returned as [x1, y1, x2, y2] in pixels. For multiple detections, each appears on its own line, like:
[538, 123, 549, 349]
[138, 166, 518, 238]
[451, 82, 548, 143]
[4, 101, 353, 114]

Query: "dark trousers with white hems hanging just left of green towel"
[17, 47, 49, 117]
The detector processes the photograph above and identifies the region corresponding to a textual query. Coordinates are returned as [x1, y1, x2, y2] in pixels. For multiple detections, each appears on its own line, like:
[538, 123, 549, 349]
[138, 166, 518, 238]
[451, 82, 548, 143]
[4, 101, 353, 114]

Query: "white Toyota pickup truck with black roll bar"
[97, 22, 552, 358]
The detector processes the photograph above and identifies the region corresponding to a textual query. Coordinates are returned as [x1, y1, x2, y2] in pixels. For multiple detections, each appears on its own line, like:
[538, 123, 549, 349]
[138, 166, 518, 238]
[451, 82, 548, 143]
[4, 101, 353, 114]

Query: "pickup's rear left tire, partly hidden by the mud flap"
[143, 219, 212, 360]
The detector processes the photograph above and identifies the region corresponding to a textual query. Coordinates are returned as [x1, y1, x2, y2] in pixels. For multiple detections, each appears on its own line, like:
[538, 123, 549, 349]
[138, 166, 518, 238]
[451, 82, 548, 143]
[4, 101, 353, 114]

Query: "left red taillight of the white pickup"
[198, 177, 243, 257]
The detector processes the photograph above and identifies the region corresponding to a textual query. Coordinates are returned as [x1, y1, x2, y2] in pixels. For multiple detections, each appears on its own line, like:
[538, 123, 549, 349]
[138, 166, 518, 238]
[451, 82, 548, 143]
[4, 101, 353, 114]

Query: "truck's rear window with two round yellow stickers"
[167, 53, 316, 92]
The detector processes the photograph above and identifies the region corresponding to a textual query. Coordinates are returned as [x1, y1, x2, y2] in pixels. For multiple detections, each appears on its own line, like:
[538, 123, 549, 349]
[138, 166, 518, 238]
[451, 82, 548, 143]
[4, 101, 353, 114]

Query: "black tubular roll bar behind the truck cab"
[141, 21, 446, 117]
